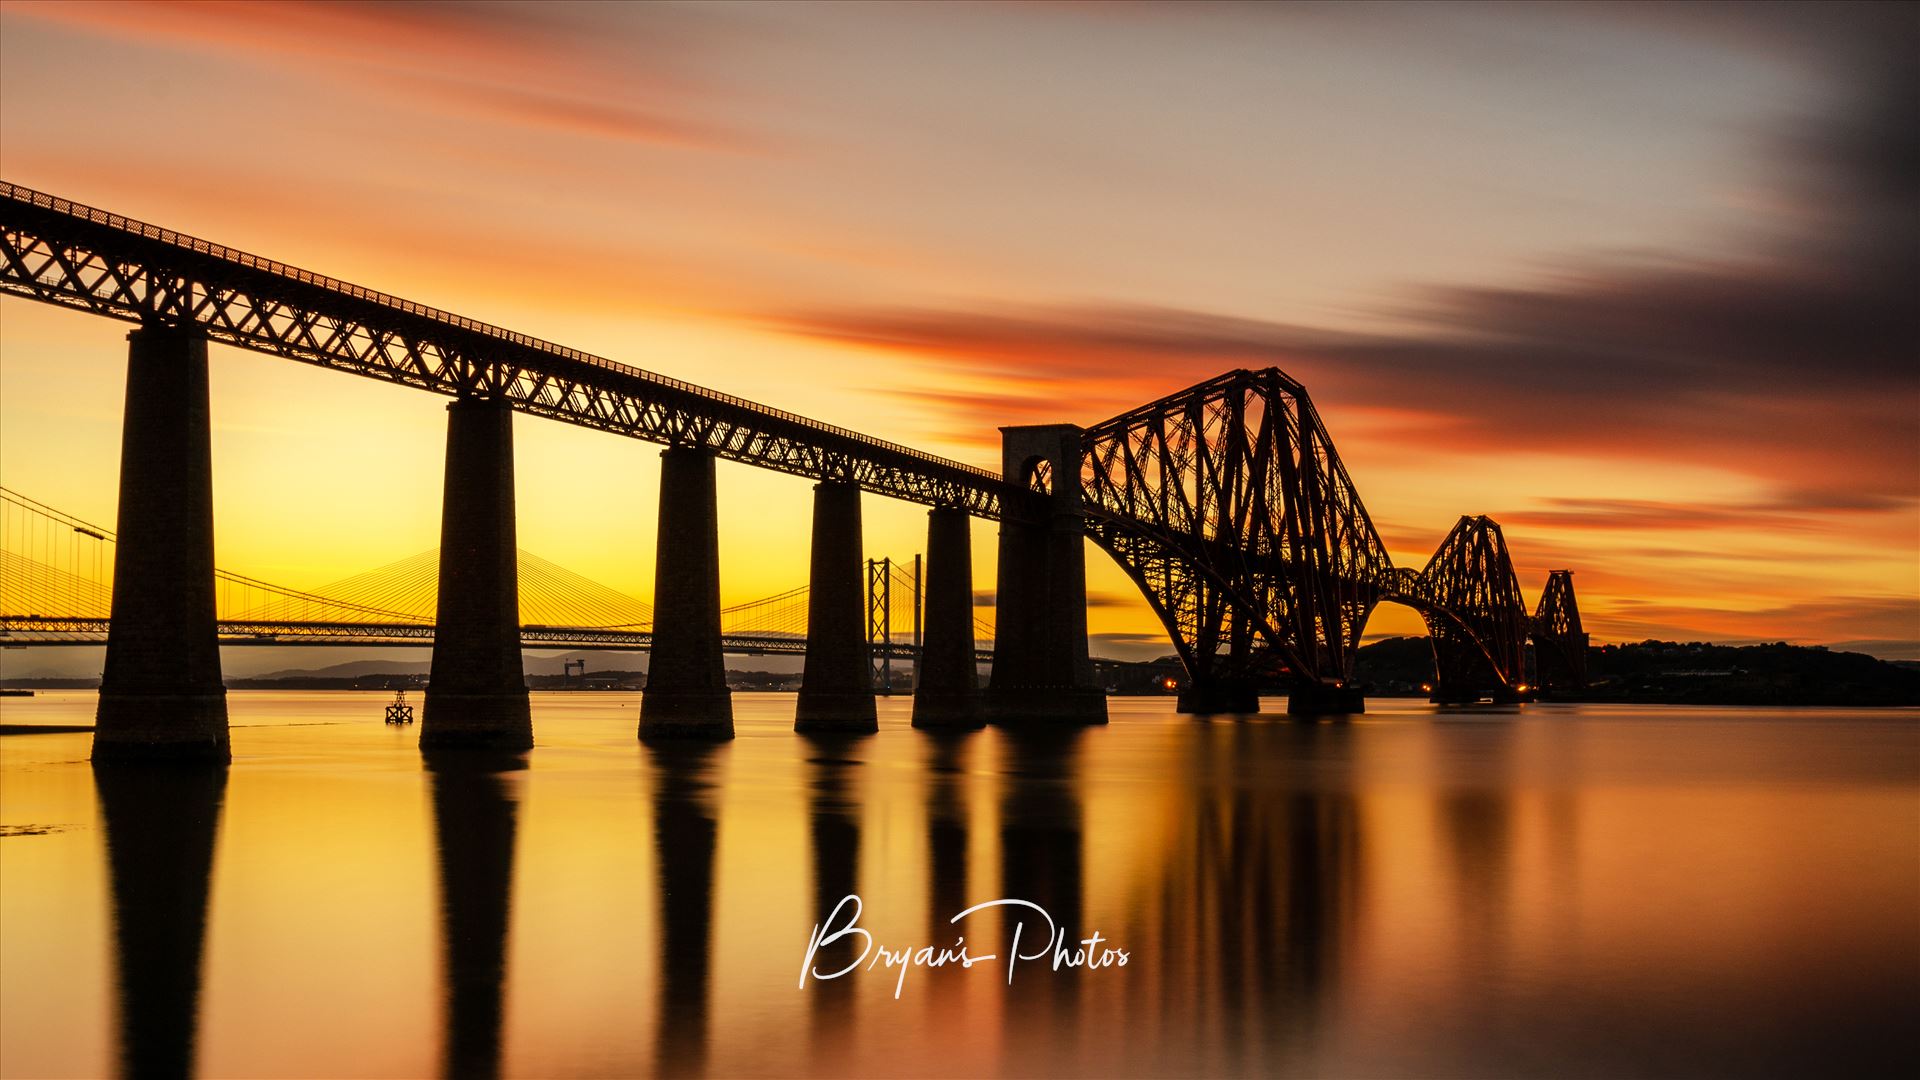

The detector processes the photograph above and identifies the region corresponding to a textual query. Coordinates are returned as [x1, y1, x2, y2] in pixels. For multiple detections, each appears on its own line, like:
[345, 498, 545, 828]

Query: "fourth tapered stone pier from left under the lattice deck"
[793, 480, 879, 732]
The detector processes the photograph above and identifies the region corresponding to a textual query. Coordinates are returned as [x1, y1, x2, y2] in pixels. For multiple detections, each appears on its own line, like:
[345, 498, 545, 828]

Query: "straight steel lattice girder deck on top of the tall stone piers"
[0, 181, 1018, 517]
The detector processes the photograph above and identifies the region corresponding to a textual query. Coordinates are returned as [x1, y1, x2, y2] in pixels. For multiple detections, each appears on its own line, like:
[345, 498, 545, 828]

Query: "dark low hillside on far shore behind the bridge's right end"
[1354, 638, 1920, 705]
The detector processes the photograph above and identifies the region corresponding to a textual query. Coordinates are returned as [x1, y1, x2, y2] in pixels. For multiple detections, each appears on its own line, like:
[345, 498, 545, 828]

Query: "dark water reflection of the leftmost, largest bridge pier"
[94, 763, 227, 1076]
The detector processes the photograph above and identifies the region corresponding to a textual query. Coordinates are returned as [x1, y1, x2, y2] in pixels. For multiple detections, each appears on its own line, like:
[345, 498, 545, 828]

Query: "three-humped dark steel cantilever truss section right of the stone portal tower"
[1081, 369, 1586, 700]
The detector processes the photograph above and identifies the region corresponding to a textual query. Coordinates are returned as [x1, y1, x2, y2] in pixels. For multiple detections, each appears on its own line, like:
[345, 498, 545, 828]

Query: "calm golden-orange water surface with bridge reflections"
[0, 692, 1920, 1076]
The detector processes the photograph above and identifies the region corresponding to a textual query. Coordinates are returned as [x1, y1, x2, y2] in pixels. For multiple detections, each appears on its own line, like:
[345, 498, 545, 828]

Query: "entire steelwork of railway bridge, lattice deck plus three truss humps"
[0, 181, 1586, 692]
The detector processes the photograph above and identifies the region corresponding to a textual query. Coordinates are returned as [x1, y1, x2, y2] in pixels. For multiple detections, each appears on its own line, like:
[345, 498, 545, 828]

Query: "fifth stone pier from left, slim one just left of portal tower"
[914, 505, 981, 730]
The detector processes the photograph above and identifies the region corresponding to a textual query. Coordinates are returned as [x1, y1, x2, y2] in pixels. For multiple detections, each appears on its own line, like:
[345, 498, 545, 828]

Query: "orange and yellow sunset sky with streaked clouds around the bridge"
[0, 2, 1920, 659]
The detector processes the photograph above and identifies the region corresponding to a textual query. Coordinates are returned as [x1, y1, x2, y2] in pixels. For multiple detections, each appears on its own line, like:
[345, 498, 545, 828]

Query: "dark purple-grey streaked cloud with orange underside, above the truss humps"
[768, 42, 1920, 503]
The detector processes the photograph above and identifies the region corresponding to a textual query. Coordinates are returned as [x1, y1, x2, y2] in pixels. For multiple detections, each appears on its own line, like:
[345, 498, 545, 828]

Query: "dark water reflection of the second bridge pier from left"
[426, 753, 526, 1078]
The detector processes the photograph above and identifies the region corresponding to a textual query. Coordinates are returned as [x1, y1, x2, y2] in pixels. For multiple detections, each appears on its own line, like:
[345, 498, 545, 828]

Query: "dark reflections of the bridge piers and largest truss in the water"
[82, 724, 1420, 1076]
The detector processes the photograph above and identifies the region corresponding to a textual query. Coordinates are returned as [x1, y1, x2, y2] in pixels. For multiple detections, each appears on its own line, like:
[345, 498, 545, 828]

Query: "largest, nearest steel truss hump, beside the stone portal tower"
[1081, 367, 1392, 684]
